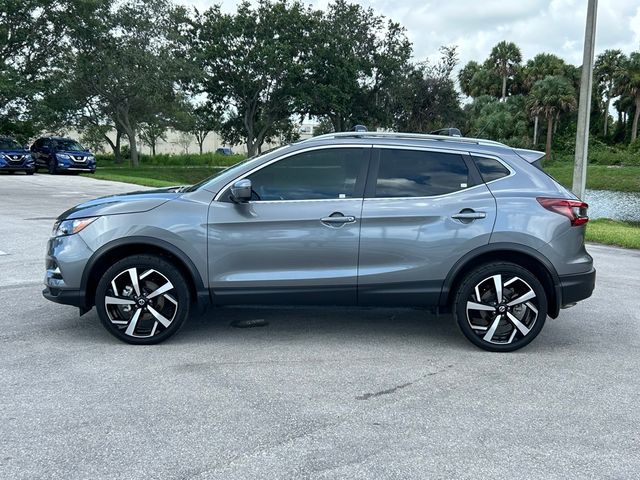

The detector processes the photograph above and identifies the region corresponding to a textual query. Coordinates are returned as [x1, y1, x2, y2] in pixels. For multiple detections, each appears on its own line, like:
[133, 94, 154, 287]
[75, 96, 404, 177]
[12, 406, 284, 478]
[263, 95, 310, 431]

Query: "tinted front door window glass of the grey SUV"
[248, 148, 368, 200]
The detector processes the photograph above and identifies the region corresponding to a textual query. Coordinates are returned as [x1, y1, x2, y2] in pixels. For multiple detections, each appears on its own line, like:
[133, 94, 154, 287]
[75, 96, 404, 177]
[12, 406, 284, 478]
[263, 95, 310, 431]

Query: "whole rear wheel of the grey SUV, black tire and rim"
[453, 262, 548, 352]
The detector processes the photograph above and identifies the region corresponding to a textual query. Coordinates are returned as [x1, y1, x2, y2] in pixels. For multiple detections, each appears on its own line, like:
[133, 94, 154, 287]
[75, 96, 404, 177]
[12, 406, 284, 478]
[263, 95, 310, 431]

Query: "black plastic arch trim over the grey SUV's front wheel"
[81, 236, 209, 310]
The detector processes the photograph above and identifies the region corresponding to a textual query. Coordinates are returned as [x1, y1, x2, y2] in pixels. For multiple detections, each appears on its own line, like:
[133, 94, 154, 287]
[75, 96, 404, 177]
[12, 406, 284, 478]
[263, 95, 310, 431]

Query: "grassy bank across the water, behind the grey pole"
[544, 162, 640, 192]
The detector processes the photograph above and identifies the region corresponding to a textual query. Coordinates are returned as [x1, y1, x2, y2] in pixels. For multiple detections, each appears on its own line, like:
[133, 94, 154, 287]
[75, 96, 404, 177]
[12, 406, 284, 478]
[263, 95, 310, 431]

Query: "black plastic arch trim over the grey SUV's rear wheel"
[440, 243, 562, 318]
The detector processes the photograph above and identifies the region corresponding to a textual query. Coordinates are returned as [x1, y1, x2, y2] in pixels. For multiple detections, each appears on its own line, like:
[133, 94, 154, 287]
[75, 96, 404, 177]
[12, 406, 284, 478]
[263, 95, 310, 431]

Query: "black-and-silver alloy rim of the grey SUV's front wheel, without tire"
[104, 267, 179, 338]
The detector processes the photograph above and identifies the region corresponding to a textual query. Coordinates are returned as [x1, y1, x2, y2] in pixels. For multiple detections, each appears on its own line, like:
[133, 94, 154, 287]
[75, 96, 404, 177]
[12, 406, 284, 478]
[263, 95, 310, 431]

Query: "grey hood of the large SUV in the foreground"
[58, 187, 181, 220]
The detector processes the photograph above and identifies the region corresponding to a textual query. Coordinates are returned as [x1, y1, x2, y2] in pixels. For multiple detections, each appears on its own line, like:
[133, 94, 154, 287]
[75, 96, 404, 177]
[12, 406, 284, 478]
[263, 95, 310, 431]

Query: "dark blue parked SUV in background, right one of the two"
[31, 137, 96, 175]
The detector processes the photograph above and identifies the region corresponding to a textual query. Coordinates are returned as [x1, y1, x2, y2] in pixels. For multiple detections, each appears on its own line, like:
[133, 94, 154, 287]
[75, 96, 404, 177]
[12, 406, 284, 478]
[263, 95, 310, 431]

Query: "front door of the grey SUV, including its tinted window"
[208, 145, 371, 304]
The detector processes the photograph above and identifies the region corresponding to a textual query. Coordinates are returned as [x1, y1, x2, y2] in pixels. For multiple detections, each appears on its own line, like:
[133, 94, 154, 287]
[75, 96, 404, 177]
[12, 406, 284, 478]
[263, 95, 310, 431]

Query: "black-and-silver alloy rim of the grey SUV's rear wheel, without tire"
[466, 274, 540, 345]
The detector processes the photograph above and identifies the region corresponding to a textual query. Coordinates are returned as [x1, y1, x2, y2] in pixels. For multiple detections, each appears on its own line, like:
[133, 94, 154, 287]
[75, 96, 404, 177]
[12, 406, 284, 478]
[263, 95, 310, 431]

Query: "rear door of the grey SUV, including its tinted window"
[358, 146, 496, 305]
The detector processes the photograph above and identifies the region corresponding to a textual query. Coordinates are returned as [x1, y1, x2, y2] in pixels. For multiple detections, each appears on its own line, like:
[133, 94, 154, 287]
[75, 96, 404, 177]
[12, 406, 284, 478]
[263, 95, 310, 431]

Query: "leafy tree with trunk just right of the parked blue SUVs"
[69, 0, 184, 166]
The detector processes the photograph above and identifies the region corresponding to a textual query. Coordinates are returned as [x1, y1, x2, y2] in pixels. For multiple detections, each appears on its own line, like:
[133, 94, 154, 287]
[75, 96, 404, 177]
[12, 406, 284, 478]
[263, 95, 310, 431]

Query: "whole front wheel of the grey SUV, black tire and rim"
[95, 255, 191, 345]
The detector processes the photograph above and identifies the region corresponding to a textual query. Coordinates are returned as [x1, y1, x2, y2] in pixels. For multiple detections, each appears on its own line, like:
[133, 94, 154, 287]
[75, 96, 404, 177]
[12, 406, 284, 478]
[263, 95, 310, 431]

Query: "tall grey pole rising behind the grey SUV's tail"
[573, 0, 598, 199]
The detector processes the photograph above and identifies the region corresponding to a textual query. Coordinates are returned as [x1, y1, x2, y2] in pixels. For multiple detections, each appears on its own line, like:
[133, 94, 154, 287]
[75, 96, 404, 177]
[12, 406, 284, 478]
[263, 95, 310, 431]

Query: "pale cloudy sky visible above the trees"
[179, 0, 640, 66]
